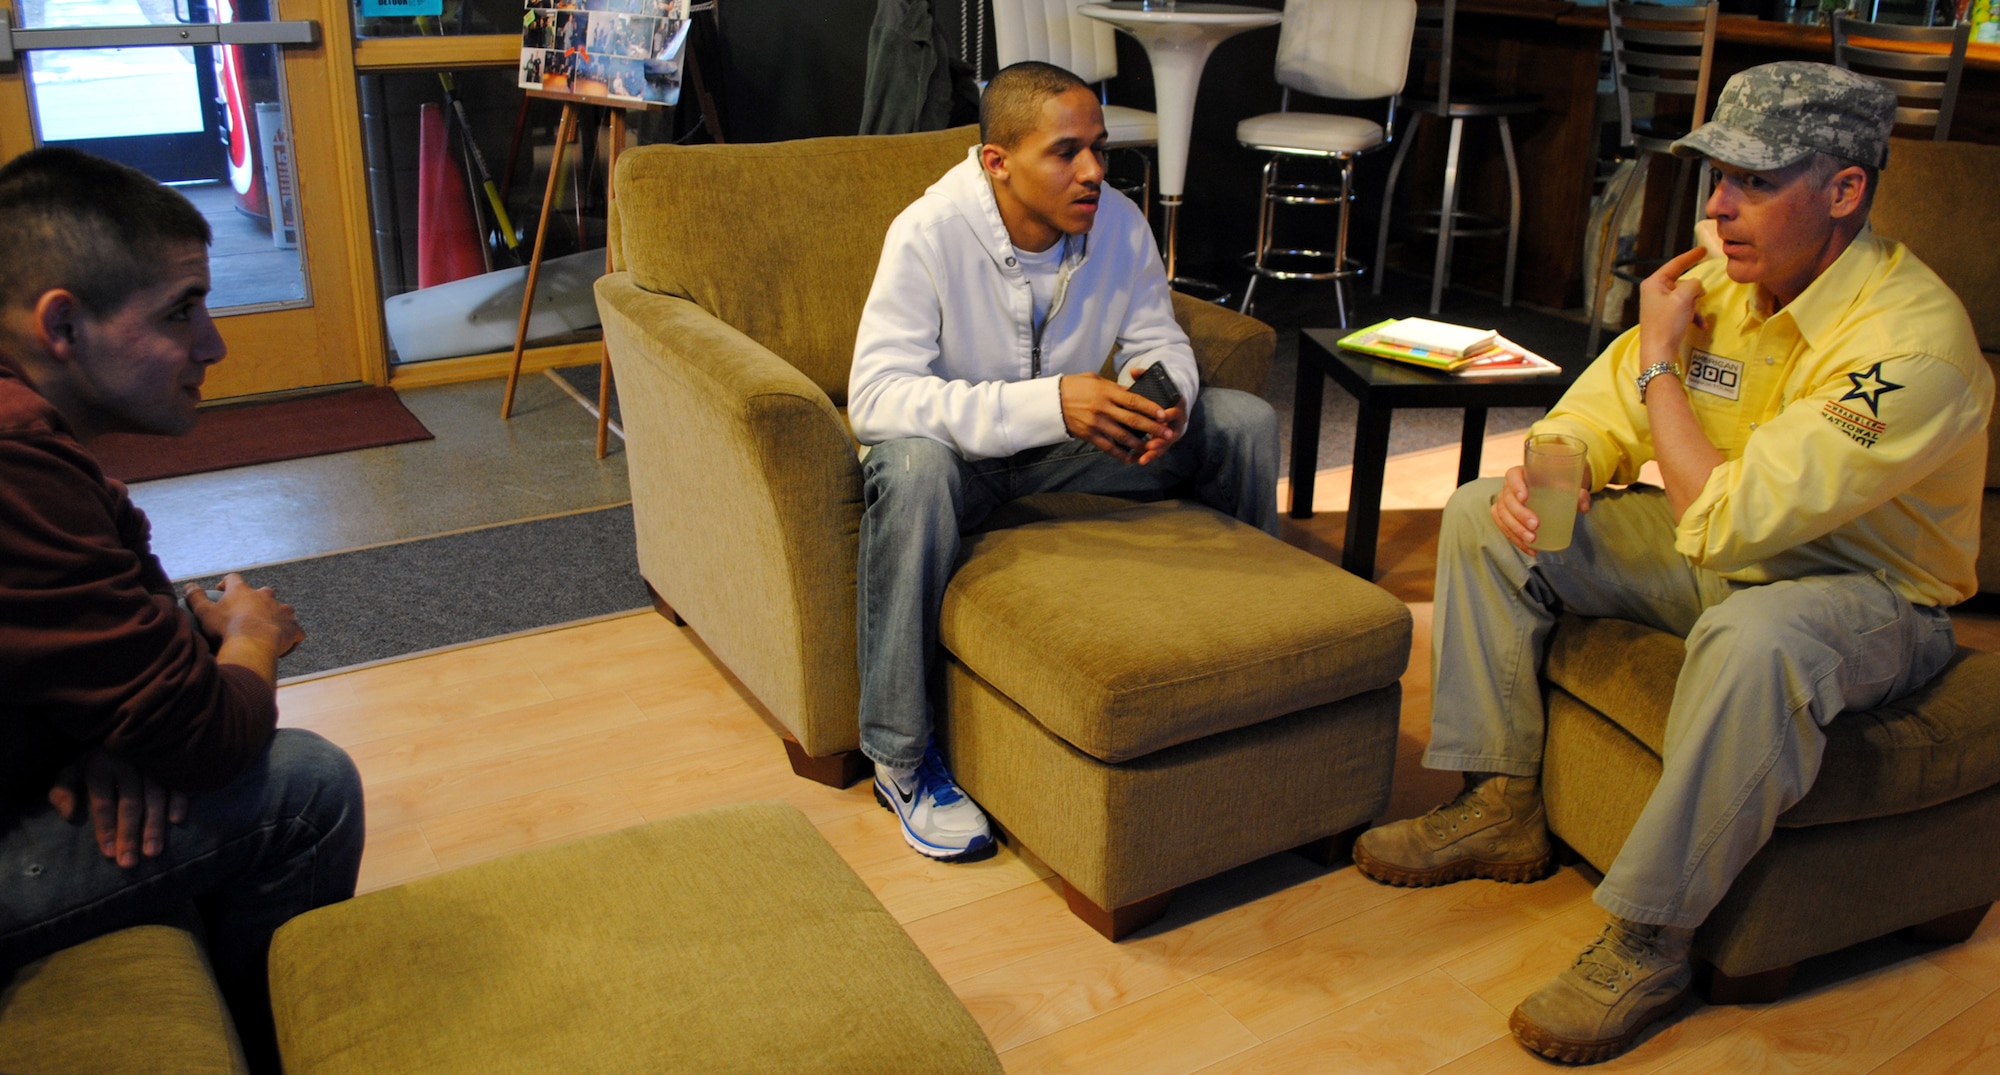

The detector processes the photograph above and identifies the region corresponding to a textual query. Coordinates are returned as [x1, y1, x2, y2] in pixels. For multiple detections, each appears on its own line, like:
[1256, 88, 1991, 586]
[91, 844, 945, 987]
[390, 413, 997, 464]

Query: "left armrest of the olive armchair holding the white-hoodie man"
[596, 272, 862, 755]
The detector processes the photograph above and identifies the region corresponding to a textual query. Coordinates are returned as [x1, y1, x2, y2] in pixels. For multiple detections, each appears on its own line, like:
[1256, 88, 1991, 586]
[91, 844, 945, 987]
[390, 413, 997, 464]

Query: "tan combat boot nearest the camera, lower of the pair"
[1508, 917, 1694, 1063]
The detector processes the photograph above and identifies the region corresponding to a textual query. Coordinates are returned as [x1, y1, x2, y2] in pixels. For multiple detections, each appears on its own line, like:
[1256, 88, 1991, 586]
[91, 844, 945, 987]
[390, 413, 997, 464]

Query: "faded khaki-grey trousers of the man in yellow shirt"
[1424, 478, 1956, 925]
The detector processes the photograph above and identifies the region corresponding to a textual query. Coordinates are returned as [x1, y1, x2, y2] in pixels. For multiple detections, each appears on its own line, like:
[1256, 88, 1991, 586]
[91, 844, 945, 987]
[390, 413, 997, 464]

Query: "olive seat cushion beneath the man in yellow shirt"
[1546, 615, 2000, 827]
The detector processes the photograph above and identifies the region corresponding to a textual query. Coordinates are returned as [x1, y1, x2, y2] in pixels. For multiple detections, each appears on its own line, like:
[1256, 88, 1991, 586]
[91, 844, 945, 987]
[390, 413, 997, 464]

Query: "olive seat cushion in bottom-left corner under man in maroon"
[0, 925, 250, 1075]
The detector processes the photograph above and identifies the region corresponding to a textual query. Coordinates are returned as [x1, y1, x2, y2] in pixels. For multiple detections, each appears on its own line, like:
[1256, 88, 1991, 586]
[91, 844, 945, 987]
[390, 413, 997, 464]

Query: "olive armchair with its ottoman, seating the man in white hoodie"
[596, 128, 1410, 927]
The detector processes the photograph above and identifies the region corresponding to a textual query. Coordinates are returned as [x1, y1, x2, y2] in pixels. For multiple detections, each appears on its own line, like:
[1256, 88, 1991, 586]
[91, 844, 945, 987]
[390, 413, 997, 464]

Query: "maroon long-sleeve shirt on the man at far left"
[0, 356, 278, 815]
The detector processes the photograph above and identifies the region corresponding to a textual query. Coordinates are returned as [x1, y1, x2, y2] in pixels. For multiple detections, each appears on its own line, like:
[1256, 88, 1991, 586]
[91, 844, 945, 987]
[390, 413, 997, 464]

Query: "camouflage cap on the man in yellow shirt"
[1674, 60, 1896, 172]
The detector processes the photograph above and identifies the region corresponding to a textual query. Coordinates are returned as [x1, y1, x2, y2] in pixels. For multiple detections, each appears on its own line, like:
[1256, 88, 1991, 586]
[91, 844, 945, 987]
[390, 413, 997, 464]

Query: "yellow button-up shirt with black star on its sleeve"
[1536, 230, 1994, 605]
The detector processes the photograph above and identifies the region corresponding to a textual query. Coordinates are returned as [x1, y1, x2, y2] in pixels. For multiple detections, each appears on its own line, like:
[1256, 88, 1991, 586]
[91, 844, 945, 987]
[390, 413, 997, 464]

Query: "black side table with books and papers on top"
[1292, 328, 1590, 579]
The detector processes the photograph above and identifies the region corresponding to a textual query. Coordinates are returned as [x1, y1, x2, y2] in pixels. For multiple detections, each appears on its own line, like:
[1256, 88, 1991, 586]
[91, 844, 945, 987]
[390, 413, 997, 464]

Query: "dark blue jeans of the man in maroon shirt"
[0, 727, 366, 1071]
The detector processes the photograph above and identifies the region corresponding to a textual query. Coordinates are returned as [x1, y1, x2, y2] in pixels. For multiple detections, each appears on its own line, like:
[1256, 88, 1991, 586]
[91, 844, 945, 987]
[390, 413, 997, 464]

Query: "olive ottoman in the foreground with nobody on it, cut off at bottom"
[270, 803, 1000, 1075]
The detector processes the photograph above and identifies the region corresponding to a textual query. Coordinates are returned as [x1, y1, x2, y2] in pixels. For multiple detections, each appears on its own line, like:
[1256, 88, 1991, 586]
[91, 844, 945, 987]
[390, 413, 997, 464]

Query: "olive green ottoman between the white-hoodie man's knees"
[940, 502, 1410, 939]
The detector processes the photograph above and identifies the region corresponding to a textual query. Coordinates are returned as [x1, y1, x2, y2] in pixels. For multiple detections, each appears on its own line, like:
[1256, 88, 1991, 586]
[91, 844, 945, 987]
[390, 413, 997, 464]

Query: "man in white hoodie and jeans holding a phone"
[848, 62, 1278, 861]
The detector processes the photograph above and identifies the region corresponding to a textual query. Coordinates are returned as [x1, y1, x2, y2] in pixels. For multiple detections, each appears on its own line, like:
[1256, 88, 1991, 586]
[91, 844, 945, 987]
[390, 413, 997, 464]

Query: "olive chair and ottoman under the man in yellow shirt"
[1542, 140, 2000, 1001]
